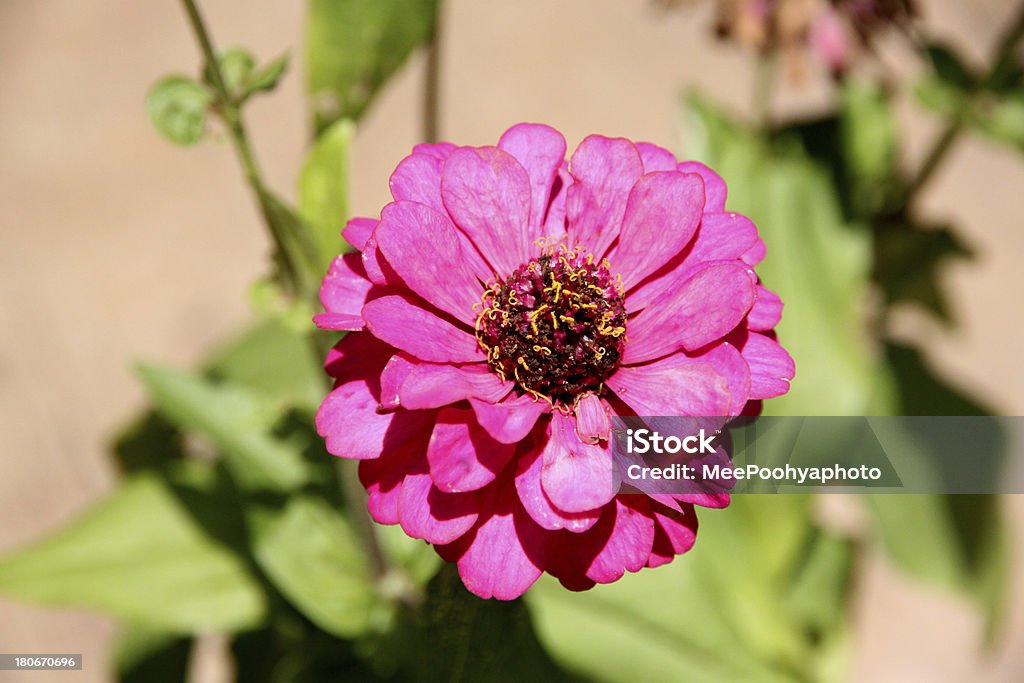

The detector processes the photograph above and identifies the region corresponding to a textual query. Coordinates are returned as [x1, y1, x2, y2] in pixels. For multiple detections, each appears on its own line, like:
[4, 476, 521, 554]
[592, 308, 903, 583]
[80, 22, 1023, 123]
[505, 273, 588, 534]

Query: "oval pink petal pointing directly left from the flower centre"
[362, 296, 484, 362]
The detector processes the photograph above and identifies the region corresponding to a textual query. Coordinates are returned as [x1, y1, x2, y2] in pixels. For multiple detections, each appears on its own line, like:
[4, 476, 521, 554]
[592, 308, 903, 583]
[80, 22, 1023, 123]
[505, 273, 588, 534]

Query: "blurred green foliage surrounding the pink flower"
[0, 0, 1024, 682]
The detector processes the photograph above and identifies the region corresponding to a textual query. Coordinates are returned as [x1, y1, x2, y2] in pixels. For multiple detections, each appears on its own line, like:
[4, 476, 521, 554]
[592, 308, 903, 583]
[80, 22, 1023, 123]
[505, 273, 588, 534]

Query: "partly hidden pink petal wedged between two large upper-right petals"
[626, 213, 758, 312]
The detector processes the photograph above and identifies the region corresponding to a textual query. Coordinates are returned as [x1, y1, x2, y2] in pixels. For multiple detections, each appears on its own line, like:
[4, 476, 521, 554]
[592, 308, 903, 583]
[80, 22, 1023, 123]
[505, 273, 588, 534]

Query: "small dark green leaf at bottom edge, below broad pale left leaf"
[113, 627, 193, 683]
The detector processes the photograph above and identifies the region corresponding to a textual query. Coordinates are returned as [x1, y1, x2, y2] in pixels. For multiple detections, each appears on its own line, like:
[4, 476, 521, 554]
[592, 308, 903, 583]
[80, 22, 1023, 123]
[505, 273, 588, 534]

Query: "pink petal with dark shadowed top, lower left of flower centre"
[427, 408, 515, 492]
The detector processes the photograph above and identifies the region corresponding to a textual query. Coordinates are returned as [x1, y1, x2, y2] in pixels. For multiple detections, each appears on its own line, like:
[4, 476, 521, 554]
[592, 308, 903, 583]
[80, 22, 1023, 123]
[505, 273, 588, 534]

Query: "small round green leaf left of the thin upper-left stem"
[145, 76, 214, 146]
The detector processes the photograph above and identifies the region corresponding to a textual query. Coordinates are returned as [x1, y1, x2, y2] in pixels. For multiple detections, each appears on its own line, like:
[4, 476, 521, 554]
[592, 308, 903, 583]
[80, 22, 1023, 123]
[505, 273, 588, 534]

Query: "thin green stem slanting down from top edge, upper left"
[181, 0, 316, 296]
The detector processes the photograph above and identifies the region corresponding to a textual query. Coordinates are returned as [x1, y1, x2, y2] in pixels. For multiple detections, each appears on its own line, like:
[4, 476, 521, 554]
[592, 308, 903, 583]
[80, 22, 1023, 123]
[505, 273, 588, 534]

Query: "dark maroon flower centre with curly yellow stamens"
[476, 245, 626, 405]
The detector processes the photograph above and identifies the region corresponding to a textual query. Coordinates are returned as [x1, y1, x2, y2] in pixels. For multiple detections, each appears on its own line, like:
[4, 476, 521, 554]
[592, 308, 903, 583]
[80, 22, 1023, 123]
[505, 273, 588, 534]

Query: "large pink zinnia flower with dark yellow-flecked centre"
[315, 124, 794, 599]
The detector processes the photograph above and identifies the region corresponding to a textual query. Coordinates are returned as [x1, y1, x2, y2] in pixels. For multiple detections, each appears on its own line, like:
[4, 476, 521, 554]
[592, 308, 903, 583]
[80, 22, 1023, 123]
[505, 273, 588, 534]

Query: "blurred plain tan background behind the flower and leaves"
[0, 0, 1024, 682]
